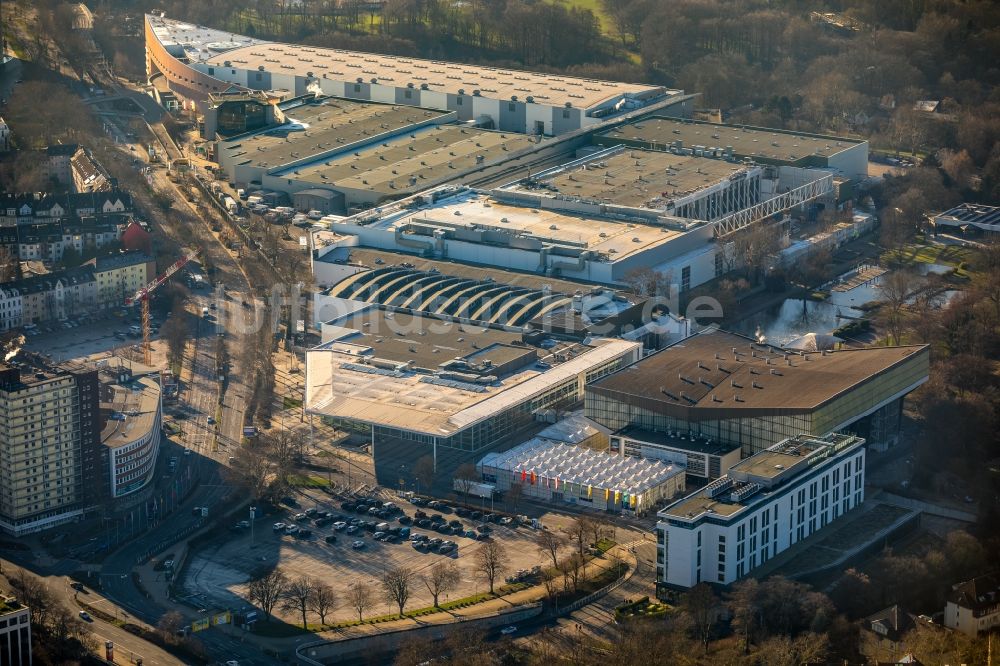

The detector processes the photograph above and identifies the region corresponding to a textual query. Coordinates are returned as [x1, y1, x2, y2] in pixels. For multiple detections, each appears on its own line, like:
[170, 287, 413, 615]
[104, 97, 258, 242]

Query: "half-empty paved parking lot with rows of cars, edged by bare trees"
[183, 488, 572, 622]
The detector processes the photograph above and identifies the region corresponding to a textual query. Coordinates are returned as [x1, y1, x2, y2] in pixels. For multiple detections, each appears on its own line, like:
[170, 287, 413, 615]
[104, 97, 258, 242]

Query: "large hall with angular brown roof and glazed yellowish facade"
[586, 329, 930, 455]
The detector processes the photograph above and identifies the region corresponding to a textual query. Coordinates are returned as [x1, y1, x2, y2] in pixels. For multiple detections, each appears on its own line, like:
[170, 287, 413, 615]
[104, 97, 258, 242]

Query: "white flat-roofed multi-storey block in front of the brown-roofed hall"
[656, 434, 865, 590]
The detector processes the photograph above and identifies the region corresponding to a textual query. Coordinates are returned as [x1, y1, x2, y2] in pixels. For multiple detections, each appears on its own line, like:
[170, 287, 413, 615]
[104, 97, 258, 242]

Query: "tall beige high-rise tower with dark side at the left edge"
[0, 359, 101, 536]
